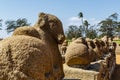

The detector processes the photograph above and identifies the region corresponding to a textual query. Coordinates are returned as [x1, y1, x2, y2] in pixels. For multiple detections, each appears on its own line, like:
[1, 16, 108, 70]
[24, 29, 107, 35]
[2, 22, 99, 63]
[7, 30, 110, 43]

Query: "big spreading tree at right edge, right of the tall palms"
[99, 13, 120, 37]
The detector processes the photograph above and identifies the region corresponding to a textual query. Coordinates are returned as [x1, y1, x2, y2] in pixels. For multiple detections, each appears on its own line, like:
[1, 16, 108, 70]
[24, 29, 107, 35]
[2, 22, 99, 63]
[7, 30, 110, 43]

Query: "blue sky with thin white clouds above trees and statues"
[0, 0, 120, 38]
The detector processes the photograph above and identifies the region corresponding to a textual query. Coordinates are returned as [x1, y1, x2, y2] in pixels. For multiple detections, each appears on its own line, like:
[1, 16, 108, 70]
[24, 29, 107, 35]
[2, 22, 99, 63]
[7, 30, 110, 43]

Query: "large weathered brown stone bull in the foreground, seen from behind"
[0, 13, 65, 80]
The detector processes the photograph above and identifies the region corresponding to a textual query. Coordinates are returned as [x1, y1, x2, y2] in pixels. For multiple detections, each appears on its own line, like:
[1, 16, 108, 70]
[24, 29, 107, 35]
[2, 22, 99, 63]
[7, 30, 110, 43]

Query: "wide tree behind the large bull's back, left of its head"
[5, 18, 30, 33]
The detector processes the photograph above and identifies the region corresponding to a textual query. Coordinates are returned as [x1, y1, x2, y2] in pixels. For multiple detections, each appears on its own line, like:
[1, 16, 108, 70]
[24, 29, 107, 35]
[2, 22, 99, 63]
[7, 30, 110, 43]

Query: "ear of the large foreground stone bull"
[37, 13, 48, 28]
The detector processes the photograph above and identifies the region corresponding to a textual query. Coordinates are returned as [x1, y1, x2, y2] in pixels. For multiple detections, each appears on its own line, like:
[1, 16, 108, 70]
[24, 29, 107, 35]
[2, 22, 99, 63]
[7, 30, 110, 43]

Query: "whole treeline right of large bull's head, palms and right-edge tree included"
[66, 12, 120, 39]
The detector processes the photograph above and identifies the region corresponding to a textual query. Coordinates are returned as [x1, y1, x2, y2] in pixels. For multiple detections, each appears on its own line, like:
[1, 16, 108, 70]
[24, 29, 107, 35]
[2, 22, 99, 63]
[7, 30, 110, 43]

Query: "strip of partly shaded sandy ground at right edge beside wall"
[111, 46, 120, 80]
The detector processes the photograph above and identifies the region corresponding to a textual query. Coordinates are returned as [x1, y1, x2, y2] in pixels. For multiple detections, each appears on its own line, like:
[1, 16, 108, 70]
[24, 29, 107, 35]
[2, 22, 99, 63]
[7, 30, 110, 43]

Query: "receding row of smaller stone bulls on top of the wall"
[61, 37, 116, 65]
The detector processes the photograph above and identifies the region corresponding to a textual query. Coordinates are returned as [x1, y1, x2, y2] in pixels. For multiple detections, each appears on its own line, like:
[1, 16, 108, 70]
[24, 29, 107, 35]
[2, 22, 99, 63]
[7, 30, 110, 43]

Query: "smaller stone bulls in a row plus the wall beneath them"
[61, 37, 117, 80]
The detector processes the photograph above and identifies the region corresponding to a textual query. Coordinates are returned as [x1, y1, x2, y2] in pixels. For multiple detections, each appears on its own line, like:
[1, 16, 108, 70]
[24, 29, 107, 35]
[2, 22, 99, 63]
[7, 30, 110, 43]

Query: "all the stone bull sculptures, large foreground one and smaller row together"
[0, 13, 115, 80]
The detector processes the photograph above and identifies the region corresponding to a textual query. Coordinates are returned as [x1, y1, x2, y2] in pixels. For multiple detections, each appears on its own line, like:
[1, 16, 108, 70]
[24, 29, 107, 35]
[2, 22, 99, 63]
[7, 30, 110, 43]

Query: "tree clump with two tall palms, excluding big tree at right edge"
[66, 12, 97, 39]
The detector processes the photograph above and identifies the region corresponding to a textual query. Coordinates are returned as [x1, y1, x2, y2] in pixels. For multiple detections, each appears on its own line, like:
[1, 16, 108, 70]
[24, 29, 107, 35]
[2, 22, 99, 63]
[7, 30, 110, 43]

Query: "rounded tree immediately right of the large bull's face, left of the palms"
[66, 25, 81, 39]
